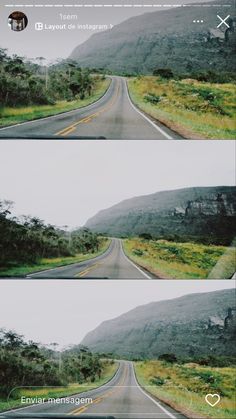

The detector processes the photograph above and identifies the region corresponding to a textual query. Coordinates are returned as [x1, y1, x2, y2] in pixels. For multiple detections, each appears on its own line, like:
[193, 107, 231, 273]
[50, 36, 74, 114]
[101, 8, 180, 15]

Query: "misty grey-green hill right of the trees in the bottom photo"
[82, 289, 235, 358]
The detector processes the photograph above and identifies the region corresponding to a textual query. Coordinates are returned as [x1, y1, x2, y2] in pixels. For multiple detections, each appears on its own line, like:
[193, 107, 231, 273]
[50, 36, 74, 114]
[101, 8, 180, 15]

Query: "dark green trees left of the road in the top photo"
[0, 49, 96, 107]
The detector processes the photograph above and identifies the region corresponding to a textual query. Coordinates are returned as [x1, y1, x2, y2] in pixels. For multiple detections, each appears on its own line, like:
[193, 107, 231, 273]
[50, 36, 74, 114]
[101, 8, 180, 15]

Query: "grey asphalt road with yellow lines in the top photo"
[0, 76, 180, 140]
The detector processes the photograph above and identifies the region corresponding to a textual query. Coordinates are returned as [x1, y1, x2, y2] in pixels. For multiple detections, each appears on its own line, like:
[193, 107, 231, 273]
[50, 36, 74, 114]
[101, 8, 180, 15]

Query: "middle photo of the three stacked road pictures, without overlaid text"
[0, 141, 236, 280]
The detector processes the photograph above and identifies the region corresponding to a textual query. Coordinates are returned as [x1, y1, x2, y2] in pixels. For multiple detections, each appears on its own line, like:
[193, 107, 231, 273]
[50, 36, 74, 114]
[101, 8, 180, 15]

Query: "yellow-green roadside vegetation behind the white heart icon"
[135, 360, 236, 419]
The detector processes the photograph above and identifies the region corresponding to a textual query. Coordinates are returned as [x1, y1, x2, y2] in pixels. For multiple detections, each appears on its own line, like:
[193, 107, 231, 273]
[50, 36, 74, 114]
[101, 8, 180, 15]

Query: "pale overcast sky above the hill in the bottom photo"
[0, 280, 234, 348]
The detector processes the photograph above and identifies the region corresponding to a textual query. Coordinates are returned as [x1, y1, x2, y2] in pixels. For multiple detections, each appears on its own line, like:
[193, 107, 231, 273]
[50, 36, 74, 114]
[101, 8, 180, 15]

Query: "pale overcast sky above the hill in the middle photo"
[0, 140, 235, 227]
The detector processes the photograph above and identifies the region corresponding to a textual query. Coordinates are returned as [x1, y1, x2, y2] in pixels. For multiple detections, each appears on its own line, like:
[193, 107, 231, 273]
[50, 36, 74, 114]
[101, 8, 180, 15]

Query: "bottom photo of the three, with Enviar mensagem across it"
[0, 280, 236, 419]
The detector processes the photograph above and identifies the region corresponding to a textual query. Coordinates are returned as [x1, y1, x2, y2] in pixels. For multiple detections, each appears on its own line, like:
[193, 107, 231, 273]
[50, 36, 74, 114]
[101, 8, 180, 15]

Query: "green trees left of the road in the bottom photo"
[0, 330, 105, 397]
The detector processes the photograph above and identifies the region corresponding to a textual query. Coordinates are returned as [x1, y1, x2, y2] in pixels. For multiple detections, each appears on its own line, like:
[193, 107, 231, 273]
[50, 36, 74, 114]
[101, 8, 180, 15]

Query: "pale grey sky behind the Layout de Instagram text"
[0, 0, 216, 62]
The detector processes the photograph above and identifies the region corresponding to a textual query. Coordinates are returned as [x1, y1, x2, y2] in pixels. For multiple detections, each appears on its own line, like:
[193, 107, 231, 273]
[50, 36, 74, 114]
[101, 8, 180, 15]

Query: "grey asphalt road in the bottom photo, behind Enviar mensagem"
[0, 361, 185, 419]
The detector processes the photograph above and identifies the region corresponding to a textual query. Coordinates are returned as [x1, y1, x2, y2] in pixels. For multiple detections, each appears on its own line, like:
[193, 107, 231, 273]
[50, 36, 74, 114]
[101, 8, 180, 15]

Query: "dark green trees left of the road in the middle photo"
[0, 201, 102, 267]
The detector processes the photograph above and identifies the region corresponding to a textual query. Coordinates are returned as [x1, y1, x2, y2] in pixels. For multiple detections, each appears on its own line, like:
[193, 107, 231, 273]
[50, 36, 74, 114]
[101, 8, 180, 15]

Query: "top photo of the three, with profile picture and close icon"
[0, 0, 236, 140]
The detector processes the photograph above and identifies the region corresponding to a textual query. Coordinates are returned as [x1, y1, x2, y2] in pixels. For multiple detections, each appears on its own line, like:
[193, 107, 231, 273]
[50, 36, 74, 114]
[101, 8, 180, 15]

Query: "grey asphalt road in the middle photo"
[27, 239, 156, 279]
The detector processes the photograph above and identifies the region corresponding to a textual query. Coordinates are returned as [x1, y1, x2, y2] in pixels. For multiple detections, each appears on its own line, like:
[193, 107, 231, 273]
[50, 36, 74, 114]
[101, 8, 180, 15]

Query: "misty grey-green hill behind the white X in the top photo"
[70, 0, 235, 74]
